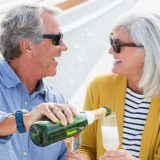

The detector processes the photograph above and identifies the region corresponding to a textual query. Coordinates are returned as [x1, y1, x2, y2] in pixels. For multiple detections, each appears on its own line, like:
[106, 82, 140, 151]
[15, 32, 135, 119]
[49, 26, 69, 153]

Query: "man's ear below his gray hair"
[19, 39, 33, 57]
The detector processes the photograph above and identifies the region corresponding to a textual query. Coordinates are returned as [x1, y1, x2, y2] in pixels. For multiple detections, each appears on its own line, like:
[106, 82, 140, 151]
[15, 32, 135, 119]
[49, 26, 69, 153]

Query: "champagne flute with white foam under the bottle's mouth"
[101, 112, 119, 151]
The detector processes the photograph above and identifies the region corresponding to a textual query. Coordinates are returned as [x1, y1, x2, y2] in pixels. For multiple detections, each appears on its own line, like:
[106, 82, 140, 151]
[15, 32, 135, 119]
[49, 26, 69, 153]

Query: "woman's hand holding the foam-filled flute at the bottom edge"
[100, 149, 139, 160]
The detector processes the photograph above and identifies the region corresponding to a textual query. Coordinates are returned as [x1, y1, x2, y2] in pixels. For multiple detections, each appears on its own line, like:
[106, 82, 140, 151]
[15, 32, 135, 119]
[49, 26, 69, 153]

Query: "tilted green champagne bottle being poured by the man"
[30, 106, 111, 147]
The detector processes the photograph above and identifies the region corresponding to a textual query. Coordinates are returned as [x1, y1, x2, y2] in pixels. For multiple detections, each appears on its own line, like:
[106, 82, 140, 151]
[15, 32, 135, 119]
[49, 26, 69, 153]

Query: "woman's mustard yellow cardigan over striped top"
[79, 74, 160, 160]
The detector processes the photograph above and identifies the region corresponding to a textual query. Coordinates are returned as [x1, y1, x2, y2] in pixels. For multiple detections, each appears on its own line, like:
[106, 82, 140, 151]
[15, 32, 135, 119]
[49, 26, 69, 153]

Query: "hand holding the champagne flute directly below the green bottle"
[66, 150, 87, 160]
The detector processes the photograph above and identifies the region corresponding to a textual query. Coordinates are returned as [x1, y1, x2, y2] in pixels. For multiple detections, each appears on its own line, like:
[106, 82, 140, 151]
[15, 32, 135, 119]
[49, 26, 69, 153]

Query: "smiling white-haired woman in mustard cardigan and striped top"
[68, 12, 160, 160]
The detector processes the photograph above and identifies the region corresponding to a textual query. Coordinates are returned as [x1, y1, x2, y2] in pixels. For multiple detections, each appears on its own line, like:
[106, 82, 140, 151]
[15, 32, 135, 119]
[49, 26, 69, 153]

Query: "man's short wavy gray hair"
[0, 5, 61, 60]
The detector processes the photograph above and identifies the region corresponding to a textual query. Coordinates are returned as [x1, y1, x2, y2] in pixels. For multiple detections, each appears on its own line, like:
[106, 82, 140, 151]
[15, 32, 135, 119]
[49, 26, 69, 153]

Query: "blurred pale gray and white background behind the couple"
[0, 0, 160, 110]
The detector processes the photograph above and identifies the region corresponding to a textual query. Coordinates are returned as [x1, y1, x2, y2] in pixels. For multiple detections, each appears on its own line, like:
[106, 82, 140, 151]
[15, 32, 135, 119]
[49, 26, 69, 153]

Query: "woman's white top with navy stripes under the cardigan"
[122, 88, 151, 158]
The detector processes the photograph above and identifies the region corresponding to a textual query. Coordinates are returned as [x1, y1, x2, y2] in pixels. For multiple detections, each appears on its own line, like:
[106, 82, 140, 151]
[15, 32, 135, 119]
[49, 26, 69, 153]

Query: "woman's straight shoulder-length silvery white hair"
[113, 11, 160, 98]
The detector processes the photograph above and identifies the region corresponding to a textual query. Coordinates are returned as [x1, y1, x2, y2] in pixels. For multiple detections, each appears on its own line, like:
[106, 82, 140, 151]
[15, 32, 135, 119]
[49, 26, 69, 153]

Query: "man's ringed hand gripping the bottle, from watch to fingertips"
[23, 103, 76, 130]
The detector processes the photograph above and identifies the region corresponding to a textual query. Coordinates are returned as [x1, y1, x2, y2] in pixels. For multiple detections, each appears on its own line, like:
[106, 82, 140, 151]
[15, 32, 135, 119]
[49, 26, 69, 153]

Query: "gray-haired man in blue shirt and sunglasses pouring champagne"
[0, 5, 76, 160]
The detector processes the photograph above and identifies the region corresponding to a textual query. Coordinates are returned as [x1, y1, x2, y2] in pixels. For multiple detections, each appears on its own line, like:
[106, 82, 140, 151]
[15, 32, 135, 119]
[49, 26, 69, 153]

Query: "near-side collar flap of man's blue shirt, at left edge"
[0, 58, 21, 88]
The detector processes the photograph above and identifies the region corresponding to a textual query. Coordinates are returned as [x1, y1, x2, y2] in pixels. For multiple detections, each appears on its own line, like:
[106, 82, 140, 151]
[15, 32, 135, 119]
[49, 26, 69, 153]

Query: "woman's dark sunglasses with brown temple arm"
[110, 36, 143, 53]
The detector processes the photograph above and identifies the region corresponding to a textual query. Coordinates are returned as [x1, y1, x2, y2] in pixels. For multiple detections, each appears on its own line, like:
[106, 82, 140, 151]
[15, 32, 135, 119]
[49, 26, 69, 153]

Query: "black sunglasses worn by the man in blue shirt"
[42, 33, 63, 46]
